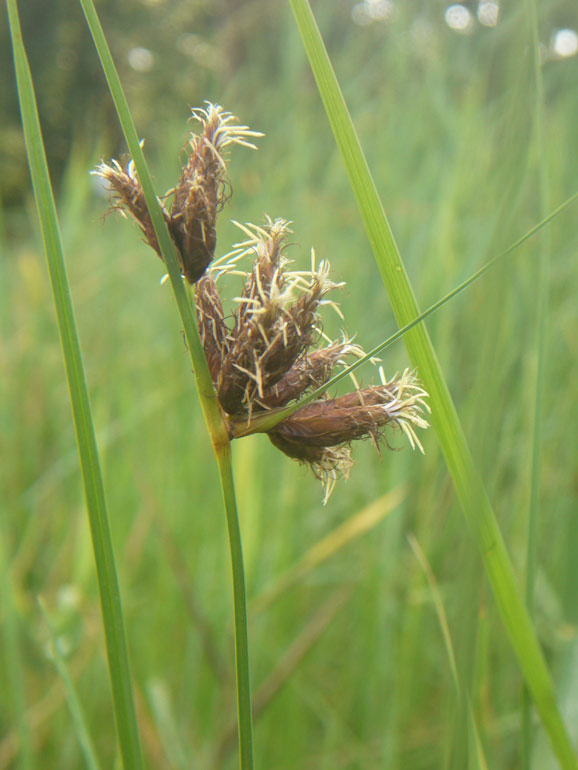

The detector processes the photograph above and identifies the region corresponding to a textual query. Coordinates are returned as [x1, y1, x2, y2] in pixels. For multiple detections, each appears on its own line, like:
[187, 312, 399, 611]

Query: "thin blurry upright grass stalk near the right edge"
[521, 0, 551, 770]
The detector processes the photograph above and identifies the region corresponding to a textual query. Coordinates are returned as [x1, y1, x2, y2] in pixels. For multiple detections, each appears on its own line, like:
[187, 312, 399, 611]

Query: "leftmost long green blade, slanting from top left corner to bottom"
[7, 0, 143, 770]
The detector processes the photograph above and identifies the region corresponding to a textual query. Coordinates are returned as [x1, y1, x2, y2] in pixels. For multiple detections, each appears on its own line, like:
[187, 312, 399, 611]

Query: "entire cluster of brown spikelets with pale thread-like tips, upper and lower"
[96, 105, 428, 499]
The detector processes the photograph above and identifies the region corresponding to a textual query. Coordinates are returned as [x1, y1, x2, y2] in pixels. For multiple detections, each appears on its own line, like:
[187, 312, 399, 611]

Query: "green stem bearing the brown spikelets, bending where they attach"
[80, 0, 253, 770]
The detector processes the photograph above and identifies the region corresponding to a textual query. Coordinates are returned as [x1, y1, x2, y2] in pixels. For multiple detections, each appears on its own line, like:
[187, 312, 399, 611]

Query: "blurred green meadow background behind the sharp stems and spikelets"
[0, 0, 578, 770]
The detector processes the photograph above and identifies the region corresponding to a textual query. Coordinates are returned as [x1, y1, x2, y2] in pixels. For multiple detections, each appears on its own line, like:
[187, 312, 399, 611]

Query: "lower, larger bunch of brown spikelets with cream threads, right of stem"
[195, 219, 429, 499]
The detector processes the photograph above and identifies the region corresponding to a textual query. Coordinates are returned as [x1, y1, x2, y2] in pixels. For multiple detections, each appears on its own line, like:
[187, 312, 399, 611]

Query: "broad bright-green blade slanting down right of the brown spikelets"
[291, 0, 578, 770]
